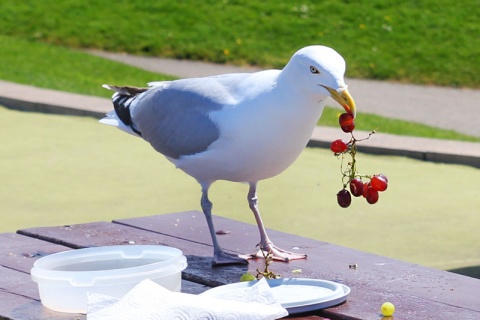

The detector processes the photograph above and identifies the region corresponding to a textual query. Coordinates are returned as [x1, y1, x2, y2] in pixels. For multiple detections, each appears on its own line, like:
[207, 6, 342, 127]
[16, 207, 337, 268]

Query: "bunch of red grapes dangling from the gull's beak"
[330, 113, 388, 208]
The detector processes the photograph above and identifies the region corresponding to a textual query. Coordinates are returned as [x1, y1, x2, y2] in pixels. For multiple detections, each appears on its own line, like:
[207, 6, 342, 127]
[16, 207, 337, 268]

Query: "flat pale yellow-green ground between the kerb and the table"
[0, 108, 480, 269]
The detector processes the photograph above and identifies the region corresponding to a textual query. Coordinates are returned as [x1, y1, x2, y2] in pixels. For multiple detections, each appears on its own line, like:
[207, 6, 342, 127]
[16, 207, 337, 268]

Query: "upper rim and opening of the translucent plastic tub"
[31, 245, 187, 286]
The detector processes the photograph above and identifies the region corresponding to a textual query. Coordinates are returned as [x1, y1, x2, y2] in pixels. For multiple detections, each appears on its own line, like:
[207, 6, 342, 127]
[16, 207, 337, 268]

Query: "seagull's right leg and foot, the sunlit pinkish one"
[248, 182, 307, 262]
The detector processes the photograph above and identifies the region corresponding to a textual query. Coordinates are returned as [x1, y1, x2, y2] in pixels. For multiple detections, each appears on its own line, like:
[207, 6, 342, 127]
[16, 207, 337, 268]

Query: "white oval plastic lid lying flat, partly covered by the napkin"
[202, 278, 350, 314]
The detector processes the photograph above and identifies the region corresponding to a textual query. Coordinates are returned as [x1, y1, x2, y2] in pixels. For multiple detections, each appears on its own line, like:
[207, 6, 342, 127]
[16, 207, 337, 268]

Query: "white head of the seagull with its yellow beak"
[282, 46, 356, 117]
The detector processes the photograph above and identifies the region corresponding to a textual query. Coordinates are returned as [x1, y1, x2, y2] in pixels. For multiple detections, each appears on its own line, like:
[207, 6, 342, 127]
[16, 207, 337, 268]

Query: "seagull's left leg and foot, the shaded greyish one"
[200, 184, 248, 266]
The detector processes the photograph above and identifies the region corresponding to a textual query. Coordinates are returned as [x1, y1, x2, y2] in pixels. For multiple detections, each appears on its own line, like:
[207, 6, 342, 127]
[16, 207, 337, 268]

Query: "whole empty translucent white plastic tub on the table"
[31, 245, 187, 313]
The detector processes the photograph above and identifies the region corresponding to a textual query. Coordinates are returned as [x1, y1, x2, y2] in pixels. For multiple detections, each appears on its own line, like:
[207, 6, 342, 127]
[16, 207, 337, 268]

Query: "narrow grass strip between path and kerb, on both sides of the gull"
[0, 36, 480, 141]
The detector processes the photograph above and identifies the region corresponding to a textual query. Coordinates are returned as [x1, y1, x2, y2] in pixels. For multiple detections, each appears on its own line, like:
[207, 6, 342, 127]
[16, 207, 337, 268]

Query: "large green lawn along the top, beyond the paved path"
[0, 0, 480, 88]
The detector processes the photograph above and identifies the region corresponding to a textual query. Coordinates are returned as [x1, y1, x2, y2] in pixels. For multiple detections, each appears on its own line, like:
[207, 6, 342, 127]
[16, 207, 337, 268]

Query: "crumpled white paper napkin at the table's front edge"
[87, 279, 288, 320]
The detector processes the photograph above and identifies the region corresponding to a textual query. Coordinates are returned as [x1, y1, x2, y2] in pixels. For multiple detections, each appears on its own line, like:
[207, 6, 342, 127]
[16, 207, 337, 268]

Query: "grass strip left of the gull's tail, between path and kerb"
[0, 36, 172, 97]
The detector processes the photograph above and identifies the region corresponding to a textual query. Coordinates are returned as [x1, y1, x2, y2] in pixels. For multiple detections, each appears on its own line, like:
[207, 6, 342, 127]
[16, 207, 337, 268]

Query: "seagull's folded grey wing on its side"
[132, 85, 223, 159]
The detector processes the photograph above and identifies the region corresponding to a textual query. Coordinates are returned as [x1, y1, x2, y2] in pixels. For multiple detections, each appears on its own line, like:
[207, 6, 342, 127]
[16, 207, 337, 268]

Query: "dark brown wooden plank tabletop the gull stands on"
[0, 211, 480, 320]
